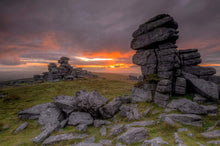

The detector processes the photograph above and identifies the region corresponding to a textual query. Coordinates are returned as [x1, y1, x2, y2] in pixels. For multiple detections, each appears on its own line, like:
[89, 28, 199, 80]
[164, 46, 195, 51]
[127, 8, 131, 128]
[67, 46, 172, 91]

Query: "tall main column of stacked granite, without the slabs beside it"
[131, 14, 180, 106]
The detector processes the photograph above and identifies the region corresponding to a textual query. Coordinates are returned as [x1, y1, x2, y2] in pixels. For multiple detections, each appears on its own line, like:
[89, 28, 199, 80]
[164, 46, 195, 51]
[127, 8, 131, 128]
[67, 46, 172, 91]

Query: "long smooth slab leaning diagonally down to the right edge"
[183, 72, 219, 101]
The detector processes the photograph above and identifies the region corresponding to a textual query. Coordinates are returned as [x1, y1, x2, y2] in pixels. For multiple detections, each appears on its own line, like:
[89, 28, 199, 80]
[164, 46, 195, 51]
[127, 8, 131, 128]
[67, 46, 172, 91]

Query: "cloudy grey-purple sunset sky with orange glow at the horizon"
[0, 0, 220, 80]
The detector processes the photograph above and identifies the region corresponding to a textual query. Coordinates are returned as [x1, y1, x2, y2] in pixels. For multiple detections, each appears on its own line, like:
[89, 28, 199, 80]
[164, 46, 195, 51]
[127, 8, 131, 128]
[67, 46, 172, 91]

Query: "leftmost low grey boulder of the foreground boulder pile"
[18, 103, 52, 120]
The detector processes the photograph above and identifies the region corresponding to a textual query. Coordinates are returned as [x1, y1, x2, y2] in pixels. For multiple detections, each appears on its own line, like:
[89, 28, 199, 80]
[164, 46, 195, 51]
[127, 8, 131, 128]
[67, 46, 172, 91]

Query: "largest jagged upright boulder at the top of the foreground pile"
[75, 90, 108, 117]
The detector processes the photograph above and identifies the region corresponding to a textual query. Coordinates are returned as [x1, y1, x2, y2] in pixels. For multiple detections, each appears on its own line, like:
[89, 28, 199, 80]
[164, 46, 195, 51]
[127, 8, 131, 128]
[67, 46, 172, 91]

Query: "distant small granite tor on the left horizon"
[34, 57, 97, 82]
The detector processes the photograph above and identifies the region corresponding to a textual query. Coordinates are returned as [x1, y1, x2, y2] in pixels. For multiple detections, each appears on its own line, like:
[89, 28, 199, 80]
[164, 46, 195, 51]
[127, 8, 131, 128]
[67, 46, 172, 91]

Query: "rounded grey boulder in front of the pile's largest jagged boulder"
[68, 112, 93, 126]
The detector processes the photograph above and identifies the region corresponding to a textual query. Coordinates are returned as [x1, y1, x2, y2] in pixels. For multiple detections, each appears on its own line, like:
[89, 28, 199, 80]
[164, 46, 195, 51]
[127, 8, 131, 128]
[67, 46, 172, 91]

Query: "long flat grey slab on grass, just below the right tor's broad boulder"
[162, 114, 202, 127]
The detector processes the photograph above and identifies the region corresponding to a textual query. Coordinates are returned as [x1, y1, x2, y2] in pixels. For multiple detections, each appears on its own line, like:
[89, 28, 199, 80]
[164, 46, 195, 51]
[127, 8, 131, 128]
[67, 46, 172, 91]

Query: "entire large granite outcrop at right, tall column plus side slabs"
[131, 14, 219, 107]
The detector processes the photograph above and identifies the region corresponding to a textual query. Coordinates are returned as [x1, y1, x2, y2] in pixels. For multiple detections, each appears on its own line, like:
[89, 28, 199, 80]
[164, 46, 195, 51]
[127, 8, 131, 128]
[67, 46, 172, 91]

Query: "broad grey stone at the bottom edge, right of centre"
[117, 127, 148, 144]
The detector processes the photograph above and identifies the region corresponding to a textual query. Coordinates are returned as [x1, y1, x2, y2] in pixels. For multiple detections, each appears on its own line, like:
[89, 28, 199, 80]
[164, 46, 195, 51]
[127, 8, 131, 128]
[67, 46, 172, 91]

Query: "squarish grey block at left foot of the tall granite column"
[131, 87, 152, 103]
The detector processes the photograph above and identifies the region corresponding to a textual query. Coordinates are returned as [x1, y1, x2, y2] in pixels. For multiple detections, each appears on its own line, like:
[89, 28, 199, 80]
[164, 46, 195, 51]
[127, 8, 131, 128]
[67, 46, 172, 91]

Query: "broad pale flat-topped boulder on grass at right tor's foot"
[167, 98, 207, 115]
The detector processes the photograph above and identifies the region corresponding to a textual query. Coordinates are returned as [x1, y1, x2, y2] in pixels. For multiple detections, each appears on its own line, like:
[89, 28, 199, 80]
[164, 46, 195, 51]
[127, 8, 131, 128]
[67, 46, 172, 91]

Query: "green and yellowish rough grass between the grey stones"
[0, 73, 220, 146]
